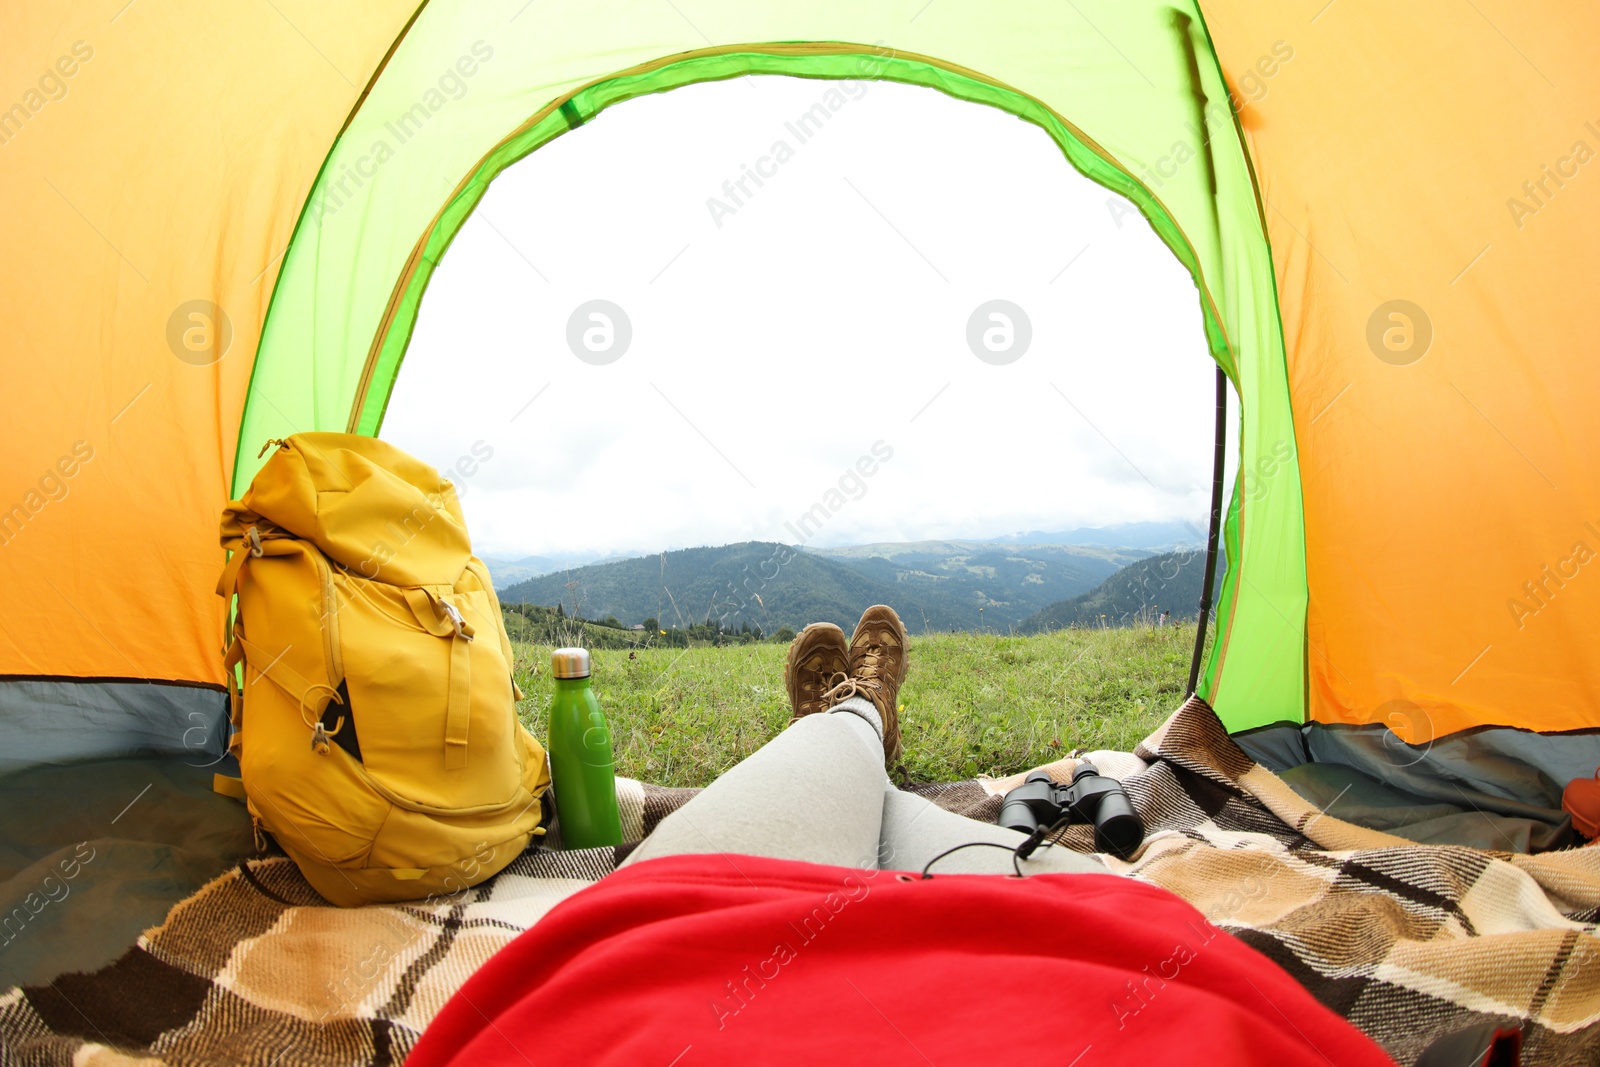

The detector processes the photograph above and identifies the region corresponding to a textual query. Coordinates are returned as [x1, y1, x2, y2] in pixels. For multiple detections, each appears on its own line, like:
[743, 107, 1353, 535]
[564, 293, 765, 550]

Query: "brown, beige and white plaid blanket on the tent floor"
[0, 701, 1600, 1067]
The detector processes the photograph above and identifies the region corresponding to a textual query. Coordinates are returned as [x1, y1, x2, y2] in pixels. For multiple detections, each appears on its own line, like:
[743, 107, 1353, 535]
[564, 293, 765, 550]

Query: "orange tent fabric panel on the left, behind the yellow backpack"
[0, 0, 416, 685]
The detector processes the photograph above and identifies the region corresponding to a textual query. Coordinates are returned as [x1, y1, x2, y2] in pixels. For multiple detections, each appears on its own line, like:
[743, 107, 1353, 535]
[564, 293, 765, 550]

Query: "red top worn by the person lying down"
[406, 854, 1392, 1067]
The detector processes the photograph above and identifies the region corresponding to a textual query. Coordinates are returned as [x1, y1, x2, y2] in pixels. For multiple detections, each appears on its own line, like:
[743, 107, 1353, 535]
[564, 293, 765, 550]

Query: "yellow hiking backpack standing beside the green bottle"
[216, 434, 550, 907]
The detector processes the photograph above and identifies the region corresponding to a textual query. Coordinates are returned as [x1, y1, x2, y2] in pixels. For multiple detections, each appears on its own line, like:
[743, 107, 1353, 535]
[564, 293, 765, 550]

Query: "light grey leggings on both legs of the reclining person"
[624, 697, 1106, 873]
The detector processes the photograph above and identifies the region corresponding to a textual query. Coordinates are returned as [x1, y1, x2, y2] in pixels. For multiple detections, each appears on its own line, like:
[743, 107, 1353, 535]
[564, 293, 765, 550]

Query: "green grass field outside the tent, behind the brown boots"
[514, 624, 1194, 785]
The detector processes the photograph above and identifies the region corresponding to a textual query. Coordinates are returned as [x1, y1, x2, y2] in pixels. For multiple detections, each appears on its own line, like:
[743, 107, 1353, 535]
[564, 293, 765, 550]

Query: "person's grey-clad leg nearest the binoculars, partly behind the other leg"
[878, 785, 1106, 875]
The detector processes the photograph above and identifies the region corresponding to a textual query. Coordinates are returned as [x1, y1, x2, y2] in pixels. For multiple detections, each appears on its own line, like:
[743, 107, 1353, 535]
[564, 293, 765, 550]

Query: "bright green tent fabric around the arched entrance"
[234, 0, 1306, 729]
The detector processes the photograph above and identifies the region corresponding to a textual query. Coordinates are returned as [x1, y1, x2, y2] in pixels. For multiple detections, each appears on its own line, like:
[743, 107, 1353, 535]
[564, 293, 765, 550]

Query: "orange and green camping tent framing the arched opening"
[0, 0, 1600, 985]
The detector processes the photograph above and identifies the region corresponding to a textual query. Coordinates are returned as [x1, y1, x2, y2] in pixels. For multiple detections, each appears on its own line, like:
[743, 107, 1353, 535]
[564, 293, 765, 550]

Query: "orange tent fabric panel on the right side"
[1203, 0, 1600, 742]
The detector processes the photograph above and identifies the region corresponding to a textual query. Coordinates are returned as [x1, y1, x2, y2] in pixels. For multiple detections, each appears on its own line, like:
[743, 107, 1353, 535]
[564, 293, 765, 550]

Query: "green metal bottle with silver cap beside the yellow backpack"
[549, 648, 622, 848]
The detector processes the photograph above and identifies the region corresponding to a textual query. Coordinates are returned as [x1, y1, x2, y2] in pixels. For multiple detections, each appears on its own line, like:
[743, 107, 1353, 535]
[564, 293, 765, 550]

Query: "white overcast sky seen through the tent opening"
[382, 77, 1213, 558]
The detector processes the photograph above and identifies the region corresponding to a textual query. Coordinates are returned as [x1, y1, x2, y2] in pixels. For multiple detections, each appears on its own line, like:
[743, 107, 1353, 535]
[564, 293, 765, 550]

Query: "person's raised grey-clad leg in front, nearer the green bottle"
[624, 697, 889, 867]
